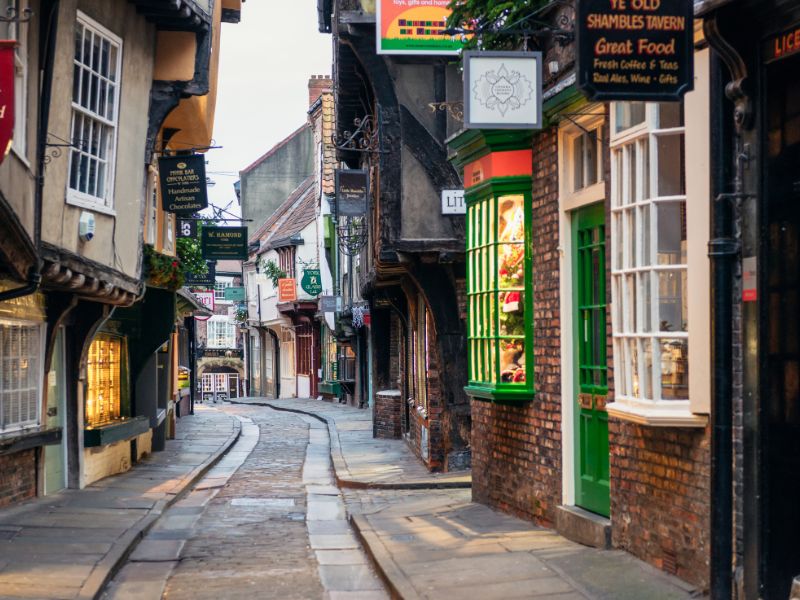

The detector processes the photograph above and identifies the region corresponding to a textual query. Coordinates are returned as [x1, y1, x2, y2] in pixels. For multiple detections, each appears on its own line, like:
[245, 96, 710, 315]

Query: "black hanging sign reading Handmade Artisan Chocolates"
[158, 154, 208, 213]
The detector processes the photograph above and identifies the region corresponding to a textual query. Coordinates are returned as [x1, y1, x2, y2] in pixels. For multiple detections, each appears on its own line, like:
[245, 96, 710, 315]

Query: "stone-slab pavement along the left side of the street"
[0, 407, 240, 599]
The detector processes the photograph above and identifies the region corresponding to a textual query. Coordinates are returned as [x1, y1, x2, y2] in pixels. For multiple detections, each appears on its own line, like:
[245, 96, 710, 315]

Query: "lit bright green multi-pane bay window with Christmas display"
[465, 176, 534, 402]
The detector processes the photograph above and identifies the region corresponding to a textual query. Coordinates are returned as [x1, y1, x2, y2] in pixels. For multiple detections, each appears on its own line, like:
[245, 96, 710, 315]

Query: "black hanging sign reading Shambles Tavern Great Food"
[576, 0, 694, 102]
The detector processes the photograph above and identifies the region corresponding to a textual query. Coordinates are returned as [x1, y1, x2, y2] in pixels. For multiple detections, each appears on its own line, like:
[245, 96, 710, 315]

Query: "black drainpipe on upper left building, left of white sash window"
[0, 0, 59, 302]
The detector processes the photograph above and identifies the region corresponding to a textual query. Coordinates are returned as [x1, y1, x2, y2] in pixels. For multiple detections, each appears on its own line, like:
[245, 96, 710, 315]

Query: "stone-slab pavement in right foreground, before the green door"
[348, 500, 698, 600]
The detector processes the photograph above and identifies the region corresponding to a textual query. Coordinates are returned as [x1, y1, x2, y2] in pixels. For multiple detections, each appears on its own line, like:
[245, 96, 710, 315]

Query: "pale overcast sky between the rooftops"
[206, 0, 331, 218]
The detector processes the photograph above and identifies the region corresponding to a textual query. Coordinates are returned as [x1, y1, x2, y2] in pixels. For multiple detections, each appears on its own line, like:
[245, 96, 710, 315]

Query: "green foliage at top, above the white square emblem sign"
[447, 0, 548, 50]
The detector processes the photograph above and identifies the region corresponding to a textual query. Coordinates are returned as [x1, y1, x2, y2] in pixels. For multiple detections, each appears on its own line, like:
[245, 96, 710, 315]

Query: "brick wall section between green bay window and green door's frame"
[472, 127, 561, 526]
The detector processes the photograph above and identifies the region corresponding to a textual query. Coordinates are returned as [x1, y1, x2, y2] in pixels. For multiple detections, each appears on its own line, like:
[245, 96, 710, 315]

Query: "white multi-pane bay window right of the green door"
[608, 103, 704, 423]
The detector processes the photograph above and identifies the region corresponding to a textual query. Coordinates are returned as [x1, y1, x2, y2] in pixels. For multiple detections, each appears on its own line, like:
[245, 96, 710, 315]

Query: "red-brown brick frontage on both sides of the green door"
[472, 128, 710, 588]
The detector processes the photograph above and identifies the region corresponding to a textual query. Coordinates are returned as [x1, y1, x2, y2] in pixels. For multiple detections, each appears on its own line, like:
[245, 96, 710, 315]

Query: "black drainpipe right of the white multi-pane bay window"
[708, 49, 744, 600]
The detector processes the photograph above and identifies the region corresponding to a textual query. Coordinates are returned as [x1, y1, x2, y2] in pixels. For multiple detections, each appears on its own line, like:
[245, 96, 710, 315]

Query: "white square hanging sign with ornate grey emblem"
[464, 52, 542, 129]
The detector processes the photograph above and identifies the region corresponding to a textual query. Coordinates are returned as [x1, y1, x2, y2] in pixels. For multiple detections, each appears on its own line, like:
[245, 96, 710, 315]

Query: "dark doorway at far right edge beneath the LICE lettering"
[759, 51, 800, 599]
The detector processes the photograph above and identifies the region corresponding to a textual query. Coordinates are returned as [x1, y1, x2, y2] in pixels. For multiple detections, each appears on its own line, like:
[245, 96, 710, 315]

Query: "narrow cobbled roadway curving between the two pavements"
[105, 405, 388, 600]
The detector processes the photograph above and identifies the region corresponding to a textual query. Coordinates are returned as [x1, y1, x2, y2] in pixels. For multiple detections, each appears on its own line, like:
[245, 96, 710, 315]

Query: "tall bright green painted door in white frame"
[572, 203, 610, 516]
